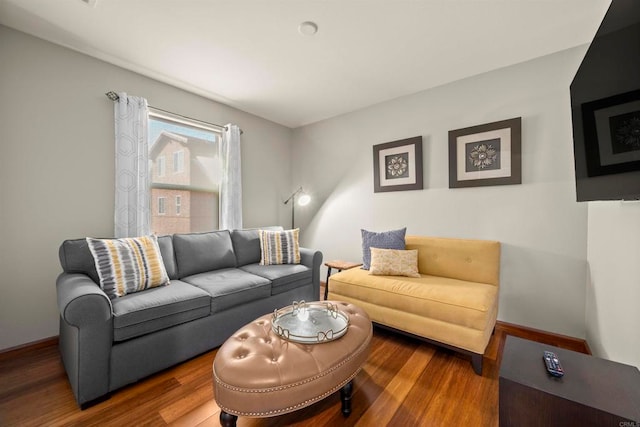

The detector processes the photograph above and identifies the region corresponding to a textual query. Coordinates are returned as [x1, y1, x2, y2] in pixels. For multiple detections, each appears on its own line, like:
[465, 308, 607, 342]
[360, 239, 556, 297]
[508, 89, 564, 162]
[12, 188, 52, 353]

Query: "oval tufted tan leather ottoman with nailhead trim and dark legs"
[213, 301, 373, 426]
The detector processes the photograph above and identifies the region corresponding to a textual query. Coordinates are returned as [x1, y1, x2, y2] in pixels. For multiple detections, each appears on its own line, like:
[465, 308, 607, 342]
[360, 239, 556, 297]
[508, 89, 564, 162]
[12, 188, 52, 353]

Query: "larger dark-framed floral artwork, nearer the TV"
[449, 117, 522, 188]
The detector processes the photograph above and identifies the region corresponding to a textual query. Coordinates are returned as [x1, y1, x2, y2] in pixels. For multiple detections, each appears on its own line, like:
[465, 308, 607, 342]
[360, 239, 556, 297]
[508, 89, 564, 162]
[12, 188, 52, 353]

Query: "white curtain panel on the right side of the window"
[220, 124, 242, 230]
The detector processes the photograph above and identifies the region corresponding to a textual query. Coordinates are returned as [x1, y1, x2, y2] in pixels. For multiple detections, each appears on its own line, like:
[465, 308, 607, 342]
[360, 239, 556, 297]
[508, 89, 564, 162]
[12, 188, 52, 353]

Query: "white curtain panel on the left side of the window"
[114, 92, 151, 237]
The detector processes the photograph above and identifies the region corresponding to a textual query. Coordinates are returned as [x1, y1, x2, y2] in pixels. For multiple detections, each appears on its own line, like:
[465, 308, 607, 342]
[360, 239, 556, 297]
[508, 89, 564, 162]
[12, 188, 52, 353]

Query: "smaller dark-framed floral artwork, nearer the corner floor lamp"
[373, 136, 422, 193]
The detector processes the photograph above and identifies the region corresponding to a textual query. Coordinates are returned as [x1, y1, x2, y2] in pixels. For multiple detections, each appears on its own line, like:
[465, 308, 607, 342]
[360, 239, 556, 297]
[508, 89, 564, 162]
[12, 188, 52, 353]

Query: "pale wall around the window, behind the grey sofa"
[0, 26, 291, 350]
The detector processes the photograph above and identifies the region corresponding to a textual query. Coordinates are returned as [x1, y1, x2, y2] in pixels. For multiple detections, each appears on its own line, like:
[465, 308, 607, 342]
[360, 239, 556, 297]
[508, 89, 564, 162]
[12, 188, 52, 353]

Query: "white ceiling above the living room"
[0, 0, 610, 128]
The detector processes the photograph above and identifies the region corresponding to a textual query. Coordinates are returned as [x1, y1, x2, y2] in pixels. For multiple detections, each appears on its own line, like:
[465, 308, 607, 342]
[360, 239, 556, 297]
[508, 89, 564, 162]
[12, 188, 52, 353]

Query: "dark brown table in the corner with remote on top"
[498, 336, 640, 427]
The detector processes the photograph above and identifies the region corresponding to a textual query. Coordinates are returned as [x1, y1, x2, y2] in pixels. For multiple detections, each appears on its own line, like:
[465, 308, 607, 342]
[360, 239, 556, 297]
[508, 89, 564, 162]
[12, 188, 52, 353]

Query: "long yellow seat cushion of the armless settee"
[329, 268, 498, 330]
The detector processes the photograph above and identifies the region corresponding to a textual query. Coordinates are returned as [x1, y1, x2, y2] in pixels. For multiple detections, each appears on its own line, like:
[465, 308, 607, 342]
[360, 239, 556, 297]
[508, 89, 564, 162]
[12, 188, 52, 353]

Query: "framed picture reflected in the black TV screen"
[582, 90, 640, 176]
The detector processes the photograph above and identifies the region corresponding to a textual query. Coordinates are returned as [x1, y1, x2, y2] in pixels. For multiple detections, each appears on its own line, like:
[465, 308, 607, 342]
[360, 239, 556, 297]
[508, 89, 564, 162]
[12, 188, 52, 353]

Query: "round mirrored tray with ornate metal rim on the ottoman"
[271, 301, 349, 344]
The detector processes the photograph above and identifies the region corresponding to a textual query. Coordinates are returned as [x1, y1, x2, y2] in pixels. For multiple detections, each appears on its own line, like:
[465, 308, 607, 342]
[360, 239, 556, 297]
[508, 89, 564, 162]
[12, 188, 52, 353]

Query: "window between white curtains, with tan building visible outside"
[149, 109, 222, 235]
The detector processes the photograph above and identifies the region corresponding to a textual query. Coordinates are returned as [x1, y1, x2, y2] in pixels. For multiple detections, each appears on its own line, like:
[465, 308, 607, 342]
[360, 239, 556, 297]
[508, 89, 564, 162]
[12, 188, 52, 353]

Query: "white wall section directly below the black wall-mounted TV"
[586, 202, 640, 367]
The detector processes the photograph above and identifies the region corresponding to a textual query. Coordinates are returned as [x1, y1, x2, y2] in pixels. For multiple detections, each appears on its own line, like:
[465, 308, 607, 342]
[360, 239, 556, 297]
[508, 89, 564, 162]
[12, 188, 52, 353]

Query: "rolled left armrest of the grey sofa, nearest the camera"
[56, 273, 113, 408]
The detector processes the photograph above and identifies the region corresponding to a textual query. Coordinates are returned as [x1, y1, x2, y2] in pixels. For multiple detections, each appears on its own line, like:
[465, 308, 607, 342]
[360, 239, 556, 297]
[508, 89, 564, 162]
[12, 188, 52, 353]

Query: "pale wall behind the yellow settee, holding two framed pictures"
[292, 47, 587, 337]
